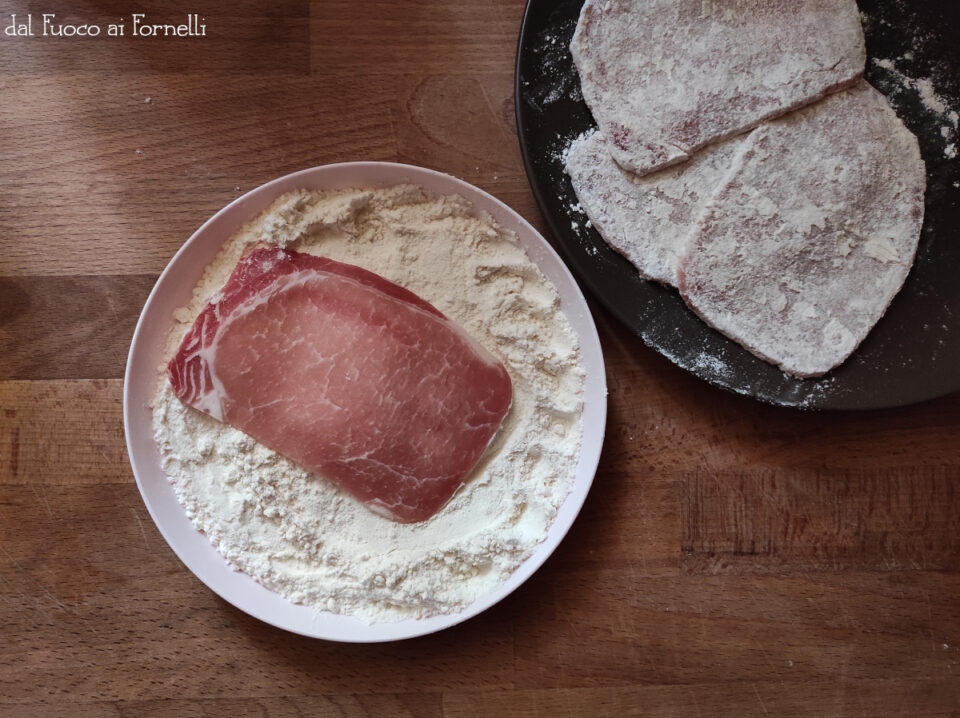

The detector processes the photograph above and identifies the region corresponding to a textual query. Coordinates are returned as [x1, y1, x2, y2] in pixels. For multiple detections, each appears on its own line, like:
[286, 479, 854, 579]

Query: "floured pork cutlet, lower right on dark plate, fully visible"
[677, 82, 926, 377]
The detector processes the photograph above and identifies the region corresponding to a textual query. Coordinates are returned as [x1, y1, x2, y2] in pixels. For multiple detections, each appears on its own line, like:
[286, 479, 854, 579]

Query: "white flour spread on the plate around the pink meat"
[153, 186, 584, 622]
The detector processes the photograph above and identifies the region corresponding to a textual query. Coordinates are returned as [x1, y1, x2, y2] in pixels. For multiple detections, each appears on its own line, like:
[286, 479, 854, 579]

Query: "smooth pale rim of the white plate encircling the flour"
[123, 161, 607, 643]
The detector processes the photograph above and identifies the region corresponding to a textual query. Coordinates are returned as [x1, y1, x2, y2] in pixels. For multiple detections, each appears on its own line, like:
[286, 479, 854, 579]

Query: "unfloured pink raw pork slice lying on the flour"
[168, 249, 512, 523]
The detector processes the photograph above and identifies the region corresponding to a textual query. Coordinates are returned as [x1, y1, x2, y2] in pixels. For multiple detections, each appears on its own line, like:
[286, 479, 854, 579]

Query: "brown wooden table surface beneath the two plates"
[0, 0, 960, 718]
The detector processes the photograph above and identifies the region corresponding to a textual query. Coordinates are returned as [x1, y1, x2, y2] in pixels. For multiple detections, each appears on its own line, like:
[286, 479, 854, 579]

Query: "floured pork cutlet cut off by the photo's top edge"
[570, 0, 866, 175]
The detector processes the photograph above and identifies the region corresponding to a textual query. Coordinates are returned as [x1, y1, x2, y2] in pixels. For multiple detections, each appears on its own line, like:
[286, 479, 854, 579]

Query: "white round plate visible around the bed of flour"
[123, 162, 607, 642]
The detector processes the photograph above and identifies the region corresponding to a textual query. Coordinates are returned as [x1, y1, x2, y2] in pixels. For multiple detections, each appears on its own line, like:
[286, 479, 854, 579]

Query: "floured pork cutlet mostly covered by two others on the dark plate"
[566, 130, 743, 286]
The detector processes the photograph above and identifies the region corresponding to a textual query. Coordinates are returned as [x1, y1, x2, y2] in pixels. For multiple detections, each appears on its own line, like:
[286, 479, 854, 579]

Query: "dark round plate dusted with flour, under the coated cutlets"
[516, 0, 960, 409]
